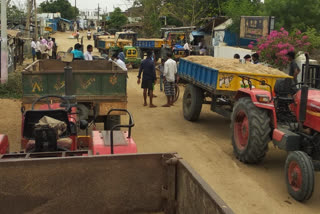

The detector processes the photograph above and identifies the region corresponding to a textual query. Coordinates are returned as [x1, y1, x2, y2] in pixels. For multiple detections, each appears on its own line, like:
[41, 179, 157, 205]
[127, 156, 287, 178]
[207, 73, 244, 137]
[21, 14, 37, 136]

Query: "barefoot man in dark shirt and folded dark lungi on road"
[137, 51, 157, 108]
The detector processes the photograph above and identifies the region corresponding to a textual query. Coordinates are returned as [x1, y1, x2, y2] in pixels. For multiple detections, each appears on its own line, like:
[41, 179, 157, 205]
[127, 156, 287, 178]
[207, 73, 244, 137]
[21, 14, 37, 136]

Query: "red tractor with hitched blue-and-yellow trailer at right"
[179, 54, 320, 202]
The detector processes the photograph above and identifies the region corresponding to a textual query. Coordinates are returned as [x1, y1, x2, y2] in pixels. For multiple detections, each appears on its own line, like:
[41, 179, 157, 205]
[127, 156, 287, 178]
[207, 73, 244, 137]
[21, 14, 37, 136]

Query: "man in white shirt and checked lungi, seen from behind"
[162, 53, 177, 107]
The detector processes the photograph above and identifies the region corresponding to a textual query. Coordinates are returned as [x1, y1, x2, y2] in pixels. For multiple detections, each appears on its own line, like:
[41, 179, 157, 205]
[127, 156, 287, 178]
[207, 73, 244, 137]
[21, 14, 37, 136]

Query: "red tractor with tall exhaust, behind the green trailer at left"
[0, 52, 137, 158]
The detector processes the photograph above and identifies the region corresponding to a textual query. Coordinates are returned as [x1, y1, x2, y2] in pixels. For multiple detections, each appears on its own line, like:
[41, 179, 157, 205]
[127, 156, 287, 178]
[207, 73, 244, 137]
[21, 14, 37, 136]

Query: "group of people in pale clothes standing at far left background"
[31, 37, 58, 61]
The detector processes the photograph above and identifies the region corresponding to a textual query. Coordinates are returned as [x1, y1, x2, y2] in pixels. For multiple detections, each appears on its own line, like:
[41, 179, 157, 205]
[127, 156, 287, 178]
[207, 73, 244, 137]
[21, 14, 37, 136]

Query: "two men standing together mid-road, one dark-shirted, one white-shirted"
[137, 51, 177, 108]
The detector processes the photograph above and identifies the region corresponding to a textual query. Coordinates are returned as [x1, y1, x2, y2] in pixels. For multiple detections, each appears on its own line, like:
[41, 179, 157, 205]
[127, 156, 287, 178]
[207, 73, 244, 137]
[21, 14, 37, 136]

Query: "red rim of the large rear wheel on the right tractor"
[234, 111, 249, 150]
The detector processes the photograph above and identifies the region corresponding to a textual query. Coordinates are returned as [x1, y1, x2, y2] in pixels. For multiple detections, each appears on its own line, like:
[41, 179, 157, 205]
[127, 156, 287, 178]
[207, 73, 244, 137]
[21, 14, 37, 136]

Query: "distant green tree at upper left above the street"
[39, 0, 79, 20]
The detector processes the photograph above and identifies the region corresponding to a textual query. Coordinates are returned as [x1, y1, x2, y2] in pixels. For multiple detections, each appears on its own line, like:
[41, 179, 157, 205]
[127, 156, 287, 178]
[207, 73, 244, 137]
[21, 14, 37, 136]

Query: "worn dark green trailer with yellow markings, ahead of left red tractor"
[22, 60, 127, 130]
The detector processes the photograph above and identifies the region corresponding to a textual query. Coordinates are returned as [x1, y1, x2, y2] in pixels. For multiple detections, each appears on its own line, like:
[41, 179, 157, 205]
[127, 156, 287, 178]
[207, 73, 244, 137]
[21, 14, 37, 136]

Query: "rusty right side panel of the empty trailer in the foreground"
[176, 160, 234, 214]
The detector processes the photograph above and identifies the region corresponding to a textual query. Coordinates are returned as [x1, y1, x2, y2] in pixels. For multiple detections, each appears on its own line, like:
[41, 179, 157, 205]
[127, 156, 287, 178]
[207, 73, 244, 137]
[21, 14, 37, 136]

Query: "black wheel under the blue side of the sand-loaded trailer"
[183, 84, 203, 121]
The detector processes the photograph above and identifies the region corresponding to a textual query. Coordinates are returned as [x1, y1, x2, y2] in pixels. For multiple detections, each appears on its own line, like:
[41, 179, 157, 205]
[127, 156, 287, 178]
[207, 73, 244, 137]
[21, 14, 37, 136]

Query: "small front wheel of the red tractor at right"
[285, 151, 314, 202]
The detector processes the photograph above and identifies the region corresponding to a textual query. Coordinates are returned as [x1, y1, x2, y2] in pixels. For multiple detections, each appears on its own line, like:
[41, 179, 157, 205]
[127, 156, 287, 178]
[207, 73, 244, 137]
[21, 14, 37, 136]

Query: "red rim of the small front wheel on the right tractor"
[288, 161, 302, 192]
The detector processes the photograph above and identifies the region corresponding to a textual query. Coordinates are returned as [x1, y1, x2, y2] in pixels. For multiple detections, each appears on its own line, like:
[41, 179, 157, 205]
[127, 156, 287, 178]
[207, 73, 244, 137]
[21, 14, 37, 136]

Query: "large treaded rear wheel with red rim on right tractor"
[231, 97, 271, 163]
